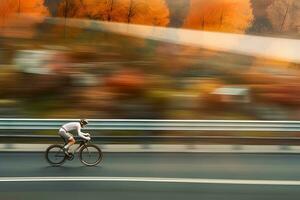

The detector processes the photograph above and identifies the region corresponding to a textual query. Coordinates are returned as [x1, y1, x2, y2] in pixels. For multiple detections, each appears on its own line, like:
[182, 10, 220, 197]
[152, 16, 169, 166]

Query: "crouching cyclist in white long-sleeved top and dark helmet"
[58, 119, 91, 156]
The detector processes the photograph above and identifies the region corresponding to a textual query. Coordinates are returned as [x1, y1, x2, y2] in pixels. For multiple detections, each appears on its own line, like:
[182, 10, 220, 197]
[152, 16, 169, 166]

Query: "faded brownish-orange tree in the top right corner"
[267, 0, 300, 32]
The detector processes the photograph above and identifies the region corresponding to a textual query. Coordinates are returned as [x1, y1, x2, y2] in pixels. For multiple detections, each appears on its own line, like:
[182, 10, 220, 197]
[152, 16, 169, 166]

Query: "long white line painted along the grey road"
[0, 177, 300, 186]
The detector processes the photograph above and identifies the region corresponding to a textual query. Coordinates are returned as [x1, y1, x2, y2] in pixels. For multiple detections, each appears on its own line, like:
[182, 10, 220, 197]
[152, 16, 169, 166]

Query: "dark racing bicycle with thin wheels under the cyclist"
[45, 135, 103, 167]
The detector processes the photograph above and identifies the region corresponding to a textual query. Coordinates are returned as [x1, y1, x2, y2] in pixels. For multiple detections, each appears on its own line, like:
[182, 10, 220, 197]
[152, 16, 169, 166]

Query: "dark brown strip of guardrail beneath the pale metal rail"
[0, 135, 300, 145]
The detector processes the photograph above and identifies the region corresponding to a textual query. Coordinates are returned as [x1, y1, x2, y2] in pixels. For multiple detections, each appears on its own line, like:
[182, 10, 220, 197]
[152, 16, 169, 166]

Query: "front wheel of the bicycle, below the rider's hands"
[79, 144, 102, 166]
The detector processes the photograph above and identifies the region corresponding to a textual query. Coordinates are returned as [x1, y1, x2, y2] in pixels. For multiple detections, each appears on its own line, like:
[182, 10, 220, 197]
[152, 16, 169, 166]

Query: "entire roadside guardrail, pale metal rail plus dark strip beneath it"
[0, 118, 300, 145]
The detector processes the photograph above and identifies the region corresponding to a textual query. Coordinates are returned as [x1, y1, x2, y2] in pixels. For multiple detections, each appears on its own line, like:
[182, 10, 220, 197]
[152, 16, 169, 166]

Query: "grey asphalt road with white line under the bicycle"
[0, 153, 300, 200]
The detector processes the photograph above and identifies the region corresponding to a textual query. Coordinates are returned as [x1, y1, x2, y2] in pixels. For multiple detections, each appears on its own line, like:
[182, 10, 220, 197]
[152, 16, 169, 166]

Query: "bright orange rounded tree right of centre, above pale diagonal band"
[184, 0, 253, 33]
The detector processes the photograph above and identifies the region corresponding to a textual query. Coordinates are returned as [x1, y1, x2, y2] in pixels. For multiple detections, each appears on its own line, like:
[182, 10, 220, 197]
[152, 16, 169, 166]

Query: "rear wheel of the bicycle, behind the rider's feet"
[45, 144, 67, 166]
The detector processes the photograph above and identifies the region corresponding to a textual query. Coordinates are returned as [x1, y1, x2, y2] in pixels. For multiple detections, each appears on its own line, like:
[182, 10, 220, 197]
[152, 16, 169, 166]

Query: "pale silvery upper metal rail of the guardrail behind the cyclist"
[0, 118, 300, 132]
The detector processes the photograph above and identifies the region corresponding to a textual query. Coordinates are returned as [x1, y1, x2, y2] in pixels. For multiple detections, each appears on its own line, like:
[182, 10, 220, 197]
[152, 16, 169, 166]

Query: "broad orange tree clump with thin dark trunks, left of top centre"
[81, 0, 169, 26]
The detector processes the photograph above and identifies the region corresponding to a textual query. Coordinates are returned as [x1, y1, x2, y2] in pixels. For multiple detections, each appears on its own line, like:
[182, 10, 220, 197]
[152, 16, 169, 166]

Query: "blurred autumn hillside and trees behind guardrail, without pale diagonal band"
[0, 0, 300, 120]
